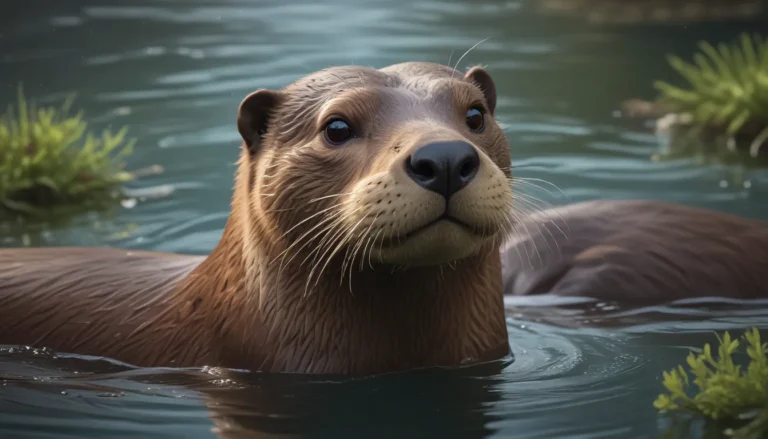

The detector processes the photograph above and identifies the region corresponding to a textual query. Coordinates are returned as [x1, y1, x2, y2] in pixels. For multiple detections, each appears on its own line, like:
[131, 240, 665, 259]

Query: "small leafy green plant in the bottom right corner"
[653, 328, 768, 438]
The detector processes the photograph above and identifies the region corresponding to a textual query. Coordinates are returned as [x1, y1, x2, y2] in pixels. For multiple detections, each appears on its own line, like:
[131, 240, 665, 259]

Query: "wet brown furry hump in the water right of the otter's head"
[502, 200, 768, 304]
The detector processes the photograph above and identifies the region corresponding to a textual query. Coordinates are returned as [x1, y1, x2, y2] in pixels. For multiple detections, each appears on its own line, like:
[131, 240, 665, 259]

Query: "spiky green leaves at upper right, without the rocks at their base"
[655, 34, 768, 157]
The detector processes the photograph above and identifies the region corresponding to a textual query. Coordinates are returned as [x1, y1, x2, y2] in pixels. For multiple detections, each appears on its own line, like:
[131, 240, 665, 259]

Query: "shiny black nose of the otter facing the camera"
[405, 142, 480, 198]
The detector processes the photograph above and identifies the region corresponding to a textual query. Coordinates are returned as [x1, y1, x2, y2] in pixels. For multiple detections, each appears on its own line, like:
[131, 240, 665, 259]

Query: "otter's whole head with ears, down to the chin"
[238, 63, 512, 265]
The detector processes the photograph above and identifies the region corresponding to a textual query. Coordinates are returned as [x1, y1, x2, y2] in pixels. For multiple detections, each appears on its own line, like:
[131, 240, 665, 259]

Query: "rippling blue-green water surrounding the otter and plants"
[0, 0, 768, 438]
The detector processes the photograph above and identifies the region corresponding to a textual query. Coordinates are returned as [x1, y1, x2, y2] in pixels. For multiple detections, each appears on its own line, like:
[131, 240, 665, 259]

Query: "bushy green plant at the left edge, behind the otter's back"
[0, 87, 134, 214]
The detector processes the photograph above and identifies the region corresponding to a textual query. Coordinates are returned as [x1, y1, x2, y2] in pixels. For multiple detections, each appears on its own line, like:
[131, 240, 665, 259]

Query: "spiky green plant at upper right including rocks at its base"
[622, 34, 768, 165]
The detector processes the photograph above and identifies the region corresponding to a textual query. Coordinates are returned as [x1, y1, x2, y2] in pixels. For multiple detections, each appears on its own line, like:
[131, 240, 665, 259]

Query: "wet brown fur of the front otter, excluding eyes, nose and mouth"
[0, 63, 512, 374]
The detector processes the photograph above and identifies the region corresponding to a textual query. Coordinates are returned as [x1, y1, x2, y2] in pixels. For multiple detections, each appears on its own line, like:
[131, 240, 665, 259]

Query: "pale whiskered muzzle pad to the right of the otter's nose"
[448, 152, 513, 239]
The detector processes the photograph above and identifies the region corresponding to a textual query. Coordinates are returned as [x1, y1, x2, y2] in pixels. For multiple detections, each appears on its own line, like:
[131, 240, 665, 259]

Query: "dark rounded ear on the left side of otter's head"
[237, 89, 282, 154]
